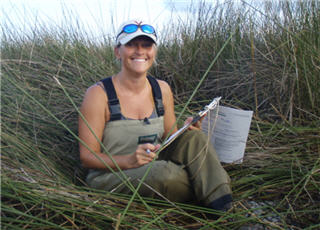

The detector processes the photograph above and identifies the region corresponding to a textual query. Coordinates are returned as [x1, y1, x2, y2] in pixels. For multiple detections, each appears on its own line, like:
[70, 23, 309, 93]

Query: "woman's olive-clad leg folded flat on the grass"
[87, 161, 194, 202]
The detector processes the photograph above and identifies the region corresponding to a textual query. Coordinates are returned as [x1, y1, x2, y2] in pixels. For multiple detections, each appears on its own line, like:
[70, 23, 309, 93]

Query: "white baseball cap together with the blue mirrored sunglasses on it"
[116, 20, 157, 45]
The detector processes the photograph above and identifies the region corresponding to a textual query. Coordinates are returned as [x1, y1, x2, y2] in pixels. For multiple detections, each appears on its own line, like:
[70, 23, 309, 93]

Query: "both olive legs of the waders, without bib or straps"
[87, 130, 231, 206]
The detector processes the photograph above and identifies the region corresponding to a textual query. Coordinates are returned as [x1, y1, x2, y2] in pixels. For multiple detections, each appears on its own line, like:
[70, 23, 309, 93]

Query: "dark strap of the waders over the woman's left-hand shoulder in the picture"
[101, 77, 121, 121]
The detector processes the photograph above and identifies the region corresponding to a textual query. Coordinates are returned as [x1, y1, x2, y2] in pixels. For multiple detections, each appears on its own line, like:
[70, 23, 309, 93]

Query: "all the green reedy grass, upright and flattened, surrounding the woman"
[1, 1, 320, 229]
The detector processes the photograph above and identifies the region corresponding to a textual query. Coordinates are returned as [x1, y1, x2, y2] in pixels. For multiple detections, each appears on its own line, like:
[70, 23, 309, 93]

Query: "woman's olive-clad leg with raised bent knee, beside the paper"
[160, 130, 232, 209]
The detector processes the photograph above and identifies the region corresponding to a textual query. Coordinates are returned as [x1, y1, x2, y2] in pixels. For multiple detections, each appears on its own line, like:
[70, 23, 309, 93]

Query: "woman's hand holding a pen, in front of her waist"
[129, 144, 160, 168]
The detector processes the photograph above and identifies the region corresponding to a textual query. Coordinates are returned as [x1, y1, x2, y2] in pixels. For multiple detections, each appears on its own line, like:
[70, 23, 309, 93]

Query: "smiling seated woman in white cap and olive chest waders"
[79, 21, 232, 210]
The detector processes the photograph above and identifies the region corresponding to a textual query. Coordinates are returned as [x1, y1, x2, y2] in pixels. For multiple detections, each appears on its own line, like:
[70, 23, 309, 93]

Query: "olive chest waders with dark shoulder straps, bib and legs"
[86, 76, 232, 209]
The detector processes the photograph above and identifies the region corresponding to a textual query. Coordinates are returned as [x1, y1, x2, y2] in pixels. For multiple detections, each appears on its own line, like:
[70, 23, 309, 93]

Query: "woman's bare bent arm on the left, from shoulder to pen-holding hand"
[79, 85, 156, 170]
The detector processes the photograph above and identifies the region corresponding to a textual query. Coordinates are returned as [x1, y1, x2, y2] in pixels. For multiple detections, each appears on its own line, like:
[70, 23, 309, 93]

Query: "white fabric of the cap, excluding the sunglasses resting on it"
[116, 20, 157, 45]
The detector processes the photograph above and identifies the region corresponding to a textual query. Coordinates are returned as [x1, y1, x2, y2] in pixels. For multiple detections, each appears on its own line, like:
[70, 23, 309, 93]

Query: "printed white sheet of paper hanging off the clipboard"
[202, 106, 253, 163]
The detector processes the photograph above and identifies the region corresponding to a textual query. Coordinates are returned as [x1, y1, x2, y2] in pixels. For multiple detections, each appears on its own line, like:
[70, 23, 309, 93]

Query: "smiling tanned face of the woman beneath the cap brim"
[115, 37, 156, 75]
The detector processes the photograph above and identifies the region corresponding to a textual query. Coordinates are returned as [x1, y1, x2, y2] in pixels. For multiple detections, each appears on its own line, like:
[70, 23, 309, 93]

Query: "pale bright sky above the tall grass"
[0, 0, 221, 40]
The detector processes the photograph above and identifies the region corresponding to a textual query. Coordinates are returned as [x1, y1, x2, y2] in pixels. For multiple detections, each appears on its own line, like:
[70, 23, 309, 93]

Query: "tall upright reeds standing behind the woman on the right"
[157, 1, 320, 124]
